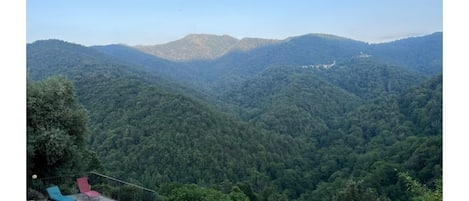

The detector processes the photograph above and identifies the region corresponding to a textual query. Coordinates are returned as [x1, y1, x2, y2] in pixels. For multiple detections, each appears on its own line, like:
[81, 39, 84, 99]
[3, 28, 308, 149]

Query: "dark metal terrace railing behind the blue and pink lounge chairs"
[28, 172, 160, 201]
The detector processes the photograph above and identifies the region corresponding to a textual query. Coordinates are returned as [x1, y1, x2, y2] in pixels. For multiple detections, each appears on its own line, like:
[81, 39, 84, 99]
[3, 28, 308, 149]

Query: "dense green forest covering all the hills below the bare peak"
[27, 32, 443, 201]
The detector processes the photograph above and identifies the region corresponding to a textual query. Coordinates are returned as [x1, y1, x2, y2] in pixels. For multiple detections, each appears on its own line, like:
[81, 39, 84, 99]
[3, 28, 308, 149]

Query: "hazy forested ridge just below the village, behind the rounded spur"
[303, 57, 425, 100]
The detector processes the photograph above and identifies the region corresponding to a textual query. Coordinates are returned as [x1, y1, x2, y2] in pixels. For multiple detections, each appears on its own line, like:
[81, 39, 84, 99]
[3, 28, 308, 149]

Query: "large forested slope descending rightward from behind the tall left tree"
[27, 40, 311, 198]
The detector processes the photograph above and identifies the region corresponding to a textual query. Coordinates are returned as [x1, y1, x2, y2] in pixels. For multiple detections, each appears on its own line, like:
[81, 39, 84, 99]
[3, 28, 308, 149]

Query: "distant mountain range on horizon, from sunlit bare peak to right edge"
[97, 33, 442, 94]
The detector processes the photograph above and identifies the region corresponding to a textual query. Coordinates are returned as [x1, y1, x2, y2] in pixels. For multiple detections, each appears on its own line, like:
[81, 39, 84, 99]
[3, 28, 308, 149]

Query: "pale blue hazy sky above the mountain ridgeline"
[26, 0, 443, 45]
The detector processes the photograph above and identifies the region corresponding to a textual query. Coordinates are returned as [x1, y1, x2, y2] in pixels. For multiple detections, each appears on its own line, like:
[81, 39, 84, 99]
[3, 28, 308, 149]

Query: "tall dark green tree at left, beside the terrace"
[27, 77, 89, 177]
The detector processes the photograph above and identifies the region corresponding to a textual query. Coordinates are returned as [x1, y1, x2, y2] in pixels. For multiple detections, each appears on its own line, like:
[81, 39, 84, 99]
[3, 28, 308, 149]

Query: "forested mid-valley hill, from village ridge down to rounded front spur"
[222, 58, 424, 136]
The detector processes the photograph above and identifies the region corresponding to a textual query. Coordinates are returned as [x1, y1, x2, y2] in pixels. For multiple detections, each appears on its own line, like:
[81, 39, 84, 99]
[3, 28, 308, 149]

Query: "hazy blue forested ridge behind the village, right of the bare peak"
[204, 34, 367, 92]
